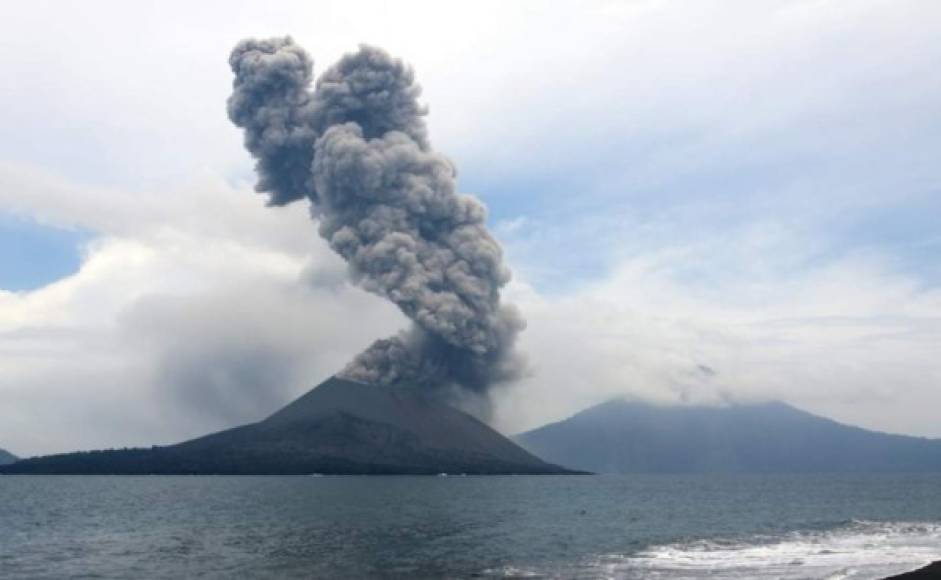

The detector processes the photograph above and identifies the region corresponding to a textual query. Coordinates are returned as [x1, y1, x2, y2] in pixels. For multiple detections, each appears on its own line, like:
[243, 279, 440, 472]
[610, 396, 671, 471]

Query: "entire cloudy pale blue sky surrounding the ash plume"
[0, 0, 941, 455]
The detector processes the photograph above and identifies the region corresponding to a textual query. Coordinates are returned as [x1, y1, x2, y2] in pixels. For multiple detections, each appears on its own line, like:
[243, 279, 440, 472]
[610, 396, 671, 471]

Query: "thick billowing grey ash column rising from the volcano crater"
[228, 38, 524, 392]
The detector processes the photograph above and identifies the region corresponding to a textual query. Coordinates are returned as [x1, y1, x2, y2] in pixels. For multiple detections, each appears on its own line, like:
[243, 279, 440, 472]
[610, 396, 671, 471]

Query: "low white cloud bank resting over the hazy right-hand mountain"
[497, 225, 941, 436]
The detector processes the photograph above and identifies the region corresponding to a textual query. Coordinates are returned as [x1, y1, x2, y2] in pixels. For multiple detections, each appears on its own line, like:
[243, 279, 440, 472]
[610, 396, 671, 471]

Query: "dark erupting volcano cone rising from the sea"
[0, 378, 580, 474]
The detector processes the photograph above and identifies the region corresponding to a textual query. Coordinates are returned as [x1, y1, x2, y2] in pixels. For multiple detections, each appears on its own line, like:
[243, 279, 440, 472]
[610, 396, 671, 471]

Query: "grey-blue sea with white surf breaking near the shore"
[0, 475, 941, 579]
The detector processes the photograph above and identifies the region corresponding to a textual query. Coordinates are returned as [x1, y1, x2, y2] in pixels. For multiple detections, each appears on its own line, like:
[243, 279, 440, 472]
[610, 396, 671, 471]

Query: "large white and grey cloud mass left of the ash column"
[0, 166, 404, 454]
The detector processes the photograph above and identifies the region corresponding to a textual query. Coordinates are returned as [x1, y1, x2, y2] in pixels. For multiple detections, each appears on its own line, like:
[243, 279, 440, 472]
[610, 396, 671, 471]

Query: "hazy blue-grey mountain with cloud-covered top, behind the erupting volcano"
[515, 401, 941, 473]
